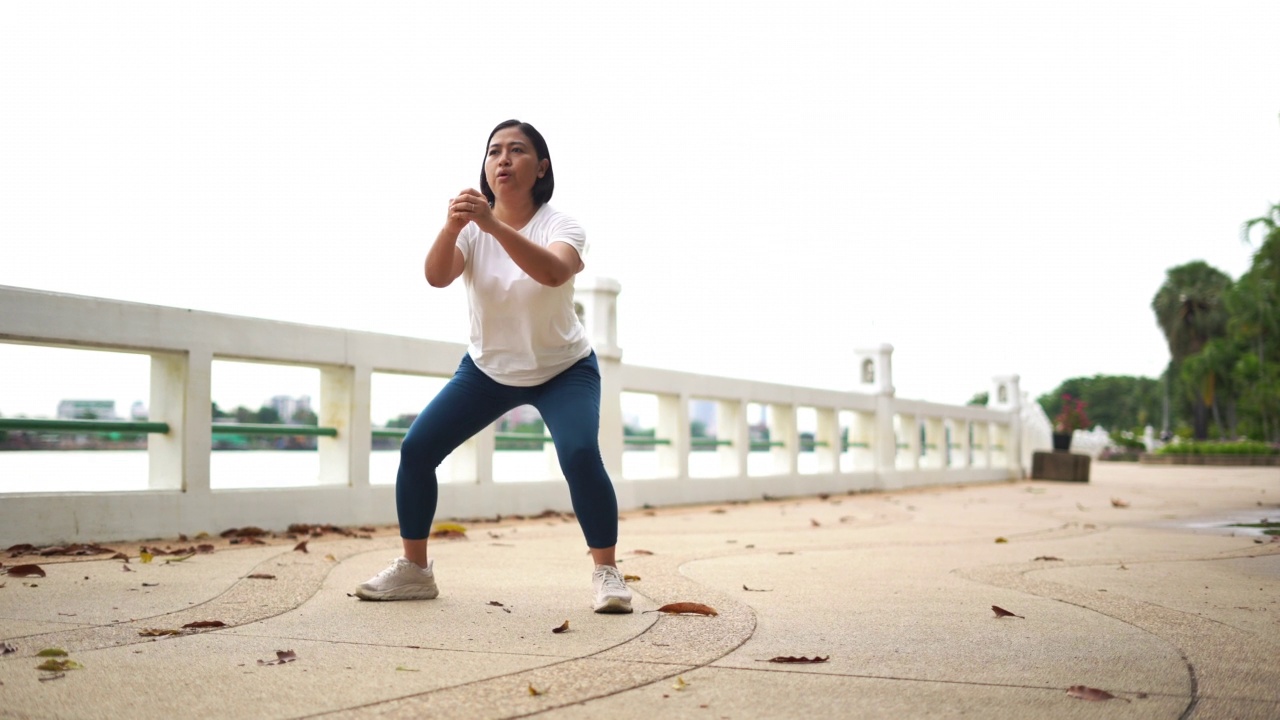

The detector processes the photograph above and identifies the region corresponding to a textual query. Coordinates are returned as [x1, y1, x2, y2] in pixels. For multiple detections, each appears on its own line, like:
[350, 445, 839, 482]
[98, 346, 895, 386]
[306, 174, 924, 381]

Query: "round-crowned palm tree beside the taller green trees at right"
[1151, 260, 1231, 439]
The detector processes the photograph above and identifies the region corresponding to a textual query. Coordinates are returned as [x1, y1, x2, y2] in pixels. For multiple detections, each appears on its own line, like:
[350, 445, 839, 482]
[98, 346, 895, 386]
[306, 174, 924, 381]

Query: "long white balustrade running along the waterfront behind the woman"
[0, 278, 1024, 544]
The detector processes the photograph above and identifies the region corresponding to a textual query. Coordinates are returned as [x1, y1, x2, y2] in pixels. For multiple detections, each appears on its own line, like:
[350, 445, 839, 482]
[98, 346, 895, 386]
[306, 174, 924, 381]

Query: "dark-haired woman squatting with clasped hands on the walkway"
[356, 120, 631, 612]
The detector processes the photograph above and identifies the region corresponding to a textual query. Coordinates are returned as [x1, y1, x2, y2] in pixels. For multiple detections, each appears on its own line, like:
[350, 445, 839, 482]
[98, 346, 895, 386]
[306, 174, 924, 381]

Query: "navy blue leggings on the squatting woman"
[396, 352, 618, 548]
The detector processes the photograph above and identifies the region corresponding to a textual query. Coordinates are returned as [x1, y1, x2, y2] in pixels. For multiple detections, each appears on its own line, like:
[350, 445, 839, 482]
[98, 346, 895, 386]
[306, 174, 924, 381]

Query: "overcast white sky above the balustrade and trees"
[0, 0, 1280, 420]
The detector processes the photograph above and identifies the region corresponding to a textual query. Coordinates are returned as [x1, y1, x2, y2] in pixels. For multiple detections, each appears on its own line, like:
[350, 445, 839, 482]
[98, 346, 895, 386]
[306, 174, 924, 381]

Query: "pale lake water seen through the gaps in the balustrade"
[0, 450, 834, 493]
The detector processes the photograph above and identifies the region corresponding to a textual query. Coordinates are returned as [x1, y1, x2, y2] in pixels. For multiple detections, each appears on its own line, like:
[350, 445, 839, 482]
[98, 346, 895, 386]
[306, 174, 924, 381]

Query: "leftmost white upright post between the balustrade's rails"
[147, 347, 214, 495]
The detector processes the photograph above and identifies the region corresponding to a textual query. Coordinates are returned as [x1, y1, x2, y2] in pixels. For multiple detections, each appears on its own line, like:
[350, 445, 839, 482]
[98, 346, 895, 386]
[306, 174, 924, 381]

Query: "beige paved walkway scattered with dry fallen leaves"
[0, 464, 1280, 720]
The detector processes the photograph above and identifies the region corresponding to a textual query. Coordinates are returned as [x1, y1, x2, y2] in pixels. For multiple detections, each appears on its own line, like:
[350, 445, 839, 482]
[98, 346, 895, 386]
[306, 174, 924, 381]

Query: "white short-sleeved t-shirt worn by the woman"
[457, 204, 591, 387]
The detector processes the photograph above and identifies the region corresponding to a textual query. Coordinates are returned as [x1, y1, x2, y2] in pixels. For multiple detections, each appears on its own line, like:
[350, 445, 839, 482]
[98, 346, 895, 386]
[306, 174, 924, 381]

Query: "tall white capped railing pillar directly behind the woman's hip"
[573, 278, 625, 482]
